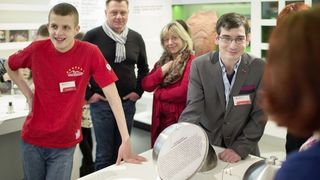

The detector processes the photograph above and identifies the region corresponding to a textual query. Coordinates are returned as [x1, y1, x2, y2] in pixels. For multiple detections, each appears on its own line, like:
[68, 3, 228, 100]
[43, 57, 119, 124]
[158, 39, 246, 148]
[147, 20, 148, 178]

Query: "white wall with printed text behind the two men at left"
[0, 0, 172, 67]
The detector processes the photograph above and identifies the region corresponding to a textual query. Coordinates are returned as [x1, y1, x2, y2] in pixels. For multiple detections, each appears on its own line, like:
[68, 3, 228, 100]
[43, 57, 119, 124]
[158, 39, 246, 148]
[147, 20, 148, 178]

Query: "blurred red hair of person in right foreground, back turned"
[260, 7, 320, 136]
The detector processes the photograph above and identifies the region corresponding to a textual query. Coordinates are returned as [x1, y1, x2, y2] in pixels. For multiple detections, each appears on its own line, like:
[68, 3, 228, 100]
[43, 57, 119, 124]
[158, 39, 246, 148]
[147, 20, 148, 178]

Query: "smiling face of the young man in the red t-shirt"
[48, 12, 80, 52]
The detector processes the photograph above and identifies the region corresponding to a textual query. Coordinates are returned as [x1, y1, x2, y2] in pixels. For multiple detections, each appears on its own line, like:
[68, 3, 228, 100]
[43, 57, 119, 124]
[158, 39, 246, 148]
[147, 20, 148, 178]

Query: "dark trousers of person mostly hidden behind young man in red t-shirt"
[79, 128, 94, 177]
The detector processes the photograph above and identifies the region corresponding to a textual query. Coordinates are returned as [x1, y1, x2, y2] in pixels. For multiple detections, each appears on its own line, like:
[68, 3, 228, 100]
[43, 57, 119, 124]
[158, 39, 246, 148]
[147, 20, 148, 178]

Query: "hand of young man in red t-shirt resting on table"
[116, 138, 147, 165]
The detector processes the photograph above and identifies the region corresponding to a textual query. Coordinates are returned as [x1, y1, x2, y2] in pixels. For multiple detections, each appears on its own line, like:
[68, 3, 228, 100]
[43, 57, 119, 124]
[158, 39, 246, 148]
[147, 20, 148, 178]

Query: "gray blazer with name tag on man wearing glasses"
[179, 52, 266, 159]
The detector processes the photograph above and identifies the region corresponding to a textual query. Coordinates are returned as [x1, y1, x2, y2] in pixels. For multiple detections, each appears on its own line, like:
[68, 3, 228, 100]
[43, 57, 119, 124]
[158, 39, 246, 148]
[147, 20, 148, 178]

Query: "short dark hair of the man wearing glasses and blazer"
[216, 13, 250, 36]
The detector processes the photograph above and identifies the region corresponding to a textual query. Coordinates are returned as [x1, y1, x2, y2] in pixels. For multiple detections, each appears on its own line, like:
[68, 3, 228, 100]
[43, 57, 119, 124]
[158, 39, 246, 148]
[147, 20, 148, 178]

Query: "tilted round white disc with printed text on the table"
[153, 122, 217, 179]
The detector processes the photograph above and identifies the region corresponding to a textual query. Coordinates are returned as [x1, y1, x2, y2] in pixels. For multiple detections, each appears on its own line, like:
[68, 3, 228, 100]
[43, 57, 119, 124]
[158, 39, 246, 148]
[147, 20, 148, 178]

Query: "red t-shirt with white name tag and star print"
[8, 40, 117, 148]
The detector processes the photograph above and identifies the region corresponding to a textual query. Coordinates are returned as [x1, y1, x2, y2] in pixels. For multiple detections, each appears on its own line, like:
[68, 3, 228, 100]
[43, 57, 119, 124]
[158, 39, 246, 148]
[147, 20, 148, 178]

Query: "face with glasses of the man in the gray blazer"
[216, 26, 249, 62]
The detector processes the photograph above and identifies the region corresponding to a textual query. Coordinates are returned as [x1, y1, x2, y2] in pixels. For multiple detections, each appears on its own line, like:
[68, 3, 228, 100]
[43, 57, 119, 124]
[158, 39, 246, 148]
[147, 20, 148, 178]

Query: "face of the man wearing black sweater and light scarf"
[105, 1, 129, 34]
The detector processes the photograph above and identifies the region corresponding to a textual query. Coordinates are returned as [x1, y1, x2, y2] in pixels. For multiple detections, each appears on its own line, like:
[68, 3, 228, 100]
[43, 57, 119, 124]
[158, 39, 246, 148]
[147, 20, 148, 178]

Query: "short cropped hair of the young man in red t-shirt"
[48, 3, 79, 26]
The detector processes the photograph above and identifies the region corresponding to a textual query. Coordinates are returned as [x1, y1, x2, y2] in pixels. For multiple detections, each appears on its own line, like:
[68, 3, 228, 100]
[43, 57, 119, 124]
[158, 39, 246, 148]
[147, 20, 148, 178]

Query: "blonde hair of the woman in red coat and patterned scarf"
[160, 21, 193, 51]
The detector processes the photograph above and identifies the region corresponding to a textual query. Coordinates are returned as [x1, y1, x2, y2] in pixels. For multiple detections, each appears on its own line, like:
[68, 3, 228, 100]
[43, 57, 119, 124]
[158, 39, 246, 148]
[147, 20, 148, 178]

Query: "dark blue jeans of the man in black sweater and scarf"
[90, 100, 136, 170]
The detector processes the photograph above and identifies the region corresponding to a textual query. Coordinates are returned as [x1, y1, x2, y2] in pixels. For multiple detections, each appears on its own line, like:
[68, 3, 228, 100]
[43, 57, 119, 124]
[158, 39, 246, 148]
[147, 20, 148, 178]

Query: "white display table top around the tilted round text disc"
[78, 146, 261, 180]
